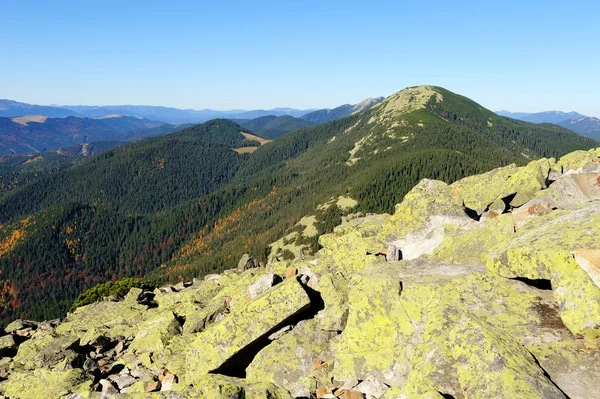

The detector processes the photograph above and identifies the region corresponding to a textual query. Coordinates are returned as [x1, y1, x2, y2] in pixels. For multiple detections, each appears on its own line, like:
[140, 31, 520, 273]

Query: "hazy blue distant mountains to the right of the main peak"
[496, 111, 600, 140]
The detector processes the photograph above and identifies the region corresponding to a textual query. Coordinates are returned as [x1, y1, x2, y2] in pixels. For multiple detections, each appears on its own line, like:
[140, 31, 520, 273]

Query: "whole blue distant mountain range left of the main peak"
[0, 97, 383, 156]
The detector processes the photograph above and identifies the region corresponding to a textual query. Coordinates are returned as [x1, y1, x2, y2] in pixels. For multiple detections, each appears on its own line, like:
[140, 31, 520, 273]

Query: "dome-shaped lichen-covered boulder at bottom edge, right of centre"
[406, 314, 564, 399]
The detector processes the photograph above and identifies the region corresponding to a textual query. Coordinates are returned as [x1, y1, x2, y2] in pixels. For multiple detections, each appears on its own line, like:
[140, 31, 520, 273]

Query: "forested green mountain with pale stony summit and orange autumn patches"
[0, 86, 597, 321]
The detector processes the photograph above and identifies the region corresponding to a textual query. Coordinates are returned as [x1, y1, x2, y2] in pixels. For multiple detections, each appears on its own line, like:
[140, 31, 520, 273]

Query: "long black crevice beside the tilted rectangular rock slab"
[210, 277, 325, 378]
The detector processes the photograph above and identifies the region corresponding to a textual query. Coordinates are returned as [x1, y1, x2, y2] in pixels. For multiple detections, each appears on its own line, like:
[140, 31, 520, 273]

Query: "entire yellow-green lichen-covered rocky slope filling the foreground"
[0, 149, 600, 399]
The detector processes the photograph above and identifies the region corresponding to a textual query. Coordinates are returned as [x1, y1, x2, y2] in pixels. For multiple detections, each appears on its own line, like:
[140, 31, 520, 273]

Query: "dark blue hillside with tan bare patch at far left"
[0, 115, 166, 155]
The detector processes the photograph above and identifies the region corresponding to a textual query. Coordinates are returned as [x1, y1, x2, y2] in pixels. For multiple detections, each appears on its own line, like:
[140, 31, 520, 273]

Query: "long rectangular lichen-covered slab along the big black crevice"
[186, 279, 311, 383]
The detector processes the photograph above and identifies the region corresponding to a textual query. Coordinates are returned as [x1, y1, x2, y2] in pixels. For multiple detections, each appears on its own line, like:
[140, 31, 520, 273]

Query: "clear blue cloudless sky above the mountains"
[0, 0, 600, 116]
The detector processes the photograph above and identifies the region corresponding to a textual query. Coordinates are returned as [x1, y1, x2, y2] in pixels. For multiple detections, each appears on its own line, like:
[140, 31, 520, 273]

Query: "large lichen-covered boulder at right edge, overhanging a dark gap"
[487, 202, 600, 337]
